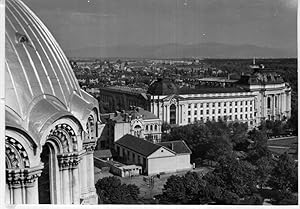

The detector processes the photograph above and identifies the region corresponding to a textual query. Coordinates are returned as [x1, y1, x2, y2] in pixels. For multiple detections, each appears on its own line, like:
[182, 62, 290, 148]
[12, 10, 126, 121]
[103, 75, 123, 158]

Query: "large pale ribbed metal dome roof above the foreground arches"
[5, 0, 98, 141]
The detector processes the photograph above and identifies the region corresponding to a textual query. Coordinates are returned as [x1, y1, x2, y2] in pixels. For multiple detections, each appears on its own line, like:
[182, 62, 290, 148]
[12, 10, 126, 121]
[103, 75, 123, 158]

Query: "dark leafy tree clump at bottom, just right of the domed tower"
[95, 176, 139, 204]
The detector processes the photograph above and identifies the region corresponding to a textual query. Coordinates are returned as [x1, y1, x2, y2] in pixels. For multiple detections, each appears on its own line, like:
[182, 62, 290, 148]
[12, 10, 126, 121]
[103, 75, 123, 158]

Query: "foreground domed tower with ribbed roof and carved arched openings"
[5, 0, 103, 204]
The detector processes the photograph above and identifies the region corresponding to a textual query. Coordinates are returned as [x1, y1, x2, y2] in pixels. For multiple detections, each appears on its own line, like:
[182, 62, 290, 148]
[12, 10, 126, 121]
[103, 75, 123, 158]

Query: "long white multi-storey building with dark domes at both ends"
[148, 66, 291, 128]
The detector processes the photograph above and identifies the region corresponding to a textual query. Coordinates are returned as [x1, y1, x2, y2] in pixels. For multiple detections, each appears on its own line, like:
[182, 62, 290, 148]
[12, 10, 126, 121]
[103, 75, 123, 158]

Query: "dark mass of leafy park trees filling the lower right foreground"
[96, 118, 298, 205]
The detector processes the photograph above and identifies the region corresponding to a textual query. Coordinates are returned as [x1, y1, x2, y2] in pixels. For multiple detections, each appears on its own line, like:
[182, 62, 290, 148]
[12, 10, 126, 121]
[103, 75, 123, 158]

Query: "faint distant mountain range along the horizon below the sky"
[66, 43, 297, 58]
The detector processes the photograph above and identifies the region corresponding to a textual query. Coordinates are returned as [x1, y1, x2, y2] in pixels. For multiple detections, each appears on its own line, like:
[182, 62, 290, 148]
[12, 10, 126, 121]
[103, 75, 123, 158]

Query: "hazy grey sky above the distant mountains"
[23, 0, 297, 51]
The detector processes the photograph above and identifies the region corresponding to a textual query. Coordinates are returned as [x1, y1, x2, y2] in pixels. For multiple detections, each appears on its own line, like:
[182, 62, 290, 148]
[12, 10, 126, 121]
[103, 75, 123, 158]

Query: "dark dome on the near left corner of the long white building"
[148, 78, 178, 95]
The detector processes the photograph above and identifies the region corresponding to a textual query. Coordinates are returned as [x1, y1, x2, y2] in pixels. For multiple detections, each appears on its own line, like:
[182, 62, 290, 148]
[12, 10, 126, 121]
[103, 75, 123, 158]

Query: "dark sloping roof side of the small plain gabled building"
[115, 134, 161, 157]
